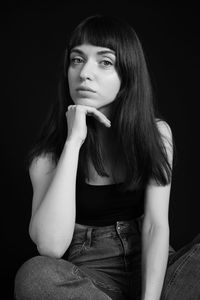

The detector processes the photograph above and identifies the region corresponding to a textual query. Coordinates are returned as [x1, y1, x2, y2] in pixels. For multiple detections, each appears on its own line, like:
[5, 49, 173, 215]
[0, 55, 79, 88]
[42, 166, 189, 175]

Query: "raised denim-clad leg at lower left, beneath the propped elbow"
[14, 256, 111, 300]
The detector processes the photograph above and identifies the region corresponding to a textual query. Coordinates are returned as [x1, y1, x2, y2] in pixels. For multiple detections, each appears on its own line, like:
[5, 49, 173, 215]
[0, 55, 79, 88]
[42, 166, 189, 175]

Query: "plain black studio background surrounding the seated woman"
[0, 1, 200, 299]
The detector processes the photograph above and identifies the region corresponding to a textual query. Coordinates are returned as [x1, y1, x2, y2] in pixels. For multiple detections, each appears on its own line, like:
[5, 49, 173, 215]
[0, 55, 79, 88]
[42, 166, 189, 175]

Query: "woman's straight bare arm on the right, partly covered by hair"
[142, 122, 172, 300]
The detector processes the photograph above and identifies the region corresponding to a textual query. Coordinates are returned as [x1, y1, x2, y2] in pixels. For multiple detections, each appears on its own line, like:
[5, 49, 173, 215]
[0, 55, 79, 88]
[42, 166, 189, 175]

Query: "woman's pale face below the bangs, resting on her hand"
[68, 44, 121, 115]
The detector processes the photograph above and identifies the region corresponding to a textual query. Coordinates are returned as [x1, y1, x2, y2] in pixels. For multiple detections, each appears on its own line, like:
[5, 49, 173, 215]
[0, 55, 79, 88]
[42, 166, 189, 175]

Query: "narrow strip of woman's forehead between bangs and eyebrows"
[70, 44, 115, 55]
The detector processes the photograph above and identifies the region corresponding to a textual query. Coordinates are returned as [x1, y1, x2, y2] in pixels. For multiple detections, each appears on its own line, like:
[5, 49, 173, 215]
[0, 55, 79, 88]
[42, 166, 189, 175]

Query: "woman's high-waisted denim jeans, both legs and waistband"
[15, 219, 200, 300]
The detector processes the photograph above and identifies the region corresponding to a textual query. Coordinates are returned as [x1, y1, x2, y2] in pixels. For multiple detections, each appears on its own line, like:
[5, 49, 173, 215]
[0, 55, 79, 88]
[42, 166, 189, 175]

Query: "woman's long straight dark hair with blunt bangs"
[27, 15, 171, 190]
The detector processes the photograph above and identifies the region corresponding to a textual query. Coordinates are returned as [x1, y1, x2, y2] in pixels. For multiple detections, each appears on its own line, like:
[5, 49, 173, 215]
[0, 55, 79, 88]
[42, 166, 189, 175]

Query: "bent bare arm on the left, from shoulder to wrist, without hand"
[29, 140, 81, 257]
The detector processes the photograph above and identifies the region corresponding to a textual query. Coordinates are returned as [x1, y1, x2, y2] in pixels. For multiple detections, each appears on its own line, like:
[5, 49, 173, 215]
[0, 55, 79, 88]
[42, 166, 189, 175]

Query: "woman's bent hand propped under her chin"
[66, 105, 111, 145]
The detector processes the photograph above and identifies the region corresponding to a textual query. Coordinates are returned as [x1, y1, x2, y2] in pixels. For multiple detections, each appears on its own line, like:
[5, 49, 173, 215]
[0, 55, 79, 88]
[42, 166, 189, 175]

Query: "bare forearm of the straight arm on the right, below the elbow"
[142, 226, 169, 300]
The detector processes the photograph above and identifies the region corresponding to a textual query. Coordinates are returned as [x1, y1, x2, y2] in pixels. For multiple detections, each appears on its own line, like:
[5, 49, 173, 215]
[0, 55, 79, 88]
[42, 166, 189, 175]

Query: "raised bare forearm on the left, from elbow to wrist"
[29, 141, 80, 256]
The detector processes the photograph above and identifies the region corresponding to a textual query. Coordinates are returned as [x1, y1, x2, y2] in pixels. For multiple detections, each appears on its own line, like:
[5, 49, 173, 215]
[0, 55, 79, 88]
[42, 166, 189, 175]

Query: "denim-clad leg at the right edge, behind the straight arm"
[161, 235, 200, 300]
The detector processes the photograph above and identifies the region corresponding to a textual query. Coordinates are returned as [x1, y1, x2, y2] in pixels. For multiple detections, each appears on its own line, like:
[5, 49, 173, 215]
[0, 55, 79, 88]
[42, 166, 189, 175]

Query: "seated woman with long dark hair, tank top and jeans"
[15, 15, 200, 300]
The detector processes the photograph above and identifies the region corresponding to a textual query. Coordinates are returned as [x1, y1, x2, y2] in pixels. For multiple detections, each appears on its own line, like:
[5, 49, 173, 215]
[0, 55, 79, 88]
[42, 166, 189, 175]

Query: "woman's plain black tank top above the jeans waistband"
[76, 182, 144, 226]
